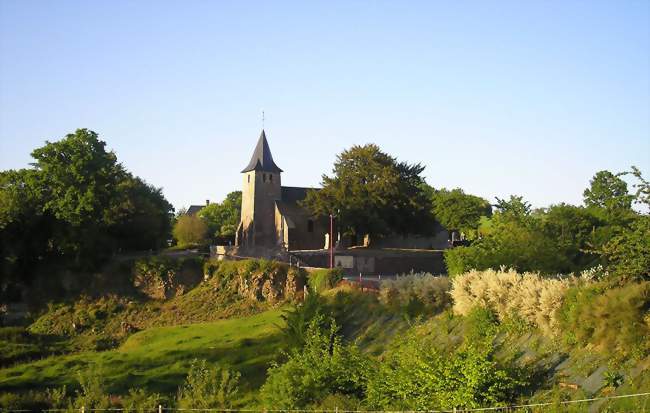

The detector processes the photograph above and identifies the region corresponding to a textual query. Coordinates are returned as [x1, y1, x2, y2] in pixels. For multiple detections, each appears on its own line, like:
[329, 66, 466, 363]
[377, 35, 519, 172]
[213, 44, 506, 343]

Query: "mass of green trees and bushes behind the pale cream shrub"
[445, 167, 650, 281]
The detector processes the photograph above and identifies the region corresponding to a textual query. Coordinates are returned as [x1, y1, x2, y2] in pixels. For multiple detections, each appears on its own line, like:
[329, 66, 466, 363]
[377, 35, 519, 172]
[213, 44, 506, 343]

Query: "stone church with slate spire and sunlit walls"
[235, 130, 329, 251]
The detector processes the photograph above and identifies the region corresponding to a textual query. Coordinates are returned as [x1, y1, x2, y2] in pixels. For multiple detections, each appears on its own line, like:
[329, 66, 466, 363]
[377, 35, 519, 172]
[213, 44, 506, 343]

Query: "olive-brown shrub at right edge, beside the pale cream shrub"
[557, 281, 650, 356]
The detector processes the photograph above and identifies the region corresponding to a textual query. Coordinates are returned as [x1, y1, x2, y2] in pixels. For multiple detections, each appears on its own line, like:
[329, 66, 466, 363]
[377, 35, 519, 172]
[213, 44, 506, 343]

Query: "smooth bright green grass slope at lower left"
[0, 309, 282, 403]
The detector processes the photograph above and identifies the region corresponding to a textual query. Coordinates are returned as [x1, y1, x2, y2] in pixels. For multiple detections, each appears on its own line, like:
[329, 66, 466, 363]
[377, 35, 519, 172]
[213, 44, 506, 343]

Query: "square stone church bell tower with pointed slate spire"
[235, 129, 282, 248]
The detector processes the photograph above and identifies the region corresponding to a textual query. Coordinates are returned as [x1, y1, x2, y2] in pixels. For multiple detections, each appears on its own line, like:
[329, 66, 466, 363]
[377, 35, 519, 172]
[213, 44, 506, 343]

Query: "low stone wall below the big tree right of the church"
[291, 248, 447, 276]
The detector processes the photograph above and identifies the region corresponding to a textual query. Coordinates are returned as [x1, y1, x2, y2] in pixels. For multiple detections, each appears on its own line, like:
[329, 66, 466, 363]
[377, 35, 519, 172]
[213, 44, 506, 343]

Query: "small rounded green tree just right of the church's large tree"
[431, 188, 492, 238]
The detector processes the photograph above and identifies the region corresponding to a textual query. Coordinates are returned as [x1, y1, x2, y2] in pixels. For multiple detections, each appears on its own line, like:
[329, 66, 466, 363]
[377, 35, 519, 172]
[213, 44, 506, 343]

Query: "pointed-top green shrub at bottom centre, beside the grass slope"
[260, 316, 370, 409]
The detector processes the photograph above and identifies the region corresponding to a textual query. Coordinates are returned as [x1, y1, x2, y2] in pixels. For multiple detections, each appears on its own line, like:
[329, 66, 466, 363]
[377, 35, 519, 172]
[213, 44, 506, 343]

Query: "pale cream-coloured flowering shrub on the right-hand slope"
[451, 270, 570, 334]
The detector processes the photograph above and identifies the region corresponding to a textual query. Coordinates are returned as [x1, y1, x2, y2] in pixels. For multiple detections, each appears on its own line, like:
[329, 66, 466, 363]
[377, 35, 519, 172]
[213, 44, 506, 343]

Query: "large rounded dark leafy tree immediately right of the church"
[304, 144, 433, 240]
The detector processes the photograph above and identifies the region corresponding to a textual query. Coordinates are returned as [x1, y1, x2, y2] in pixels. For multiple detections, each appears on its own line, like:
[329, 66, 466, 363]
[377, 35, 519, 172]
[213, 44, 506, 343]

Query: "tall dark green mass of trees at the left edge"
[0, 129, 172, 300]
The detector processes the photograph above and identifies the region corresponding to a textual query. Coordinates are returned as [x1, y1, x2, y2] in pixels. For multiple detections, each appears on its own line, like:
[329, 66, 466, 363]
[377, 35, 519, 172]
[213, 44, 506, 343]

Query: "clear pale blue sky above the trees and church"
[0, 0, 650, 208]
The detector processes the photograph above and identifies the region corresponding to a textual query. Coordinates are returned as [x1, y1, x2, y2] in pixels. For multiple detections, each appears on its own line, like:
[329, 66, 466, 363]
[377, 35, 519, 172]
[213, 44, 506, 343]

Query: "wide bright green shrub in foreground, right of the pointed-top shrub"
[367, 333, 526, 410]
